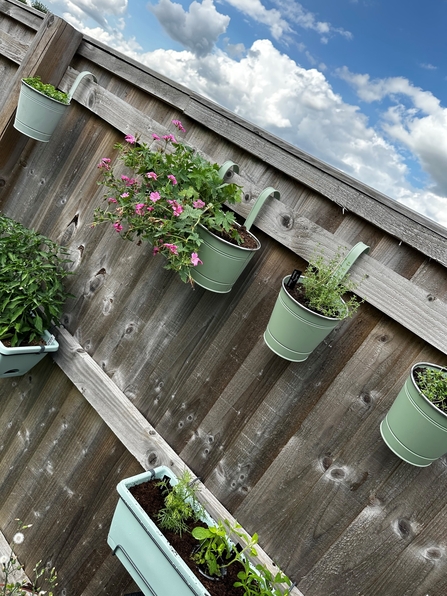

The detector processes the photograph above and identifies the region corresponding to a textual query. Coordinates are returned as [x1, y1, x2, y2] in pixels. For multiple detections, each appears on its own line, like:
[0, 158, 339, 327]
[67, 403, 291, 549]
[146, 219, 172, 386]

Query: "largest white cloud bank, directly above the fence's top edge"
[142, 40, 447, 225]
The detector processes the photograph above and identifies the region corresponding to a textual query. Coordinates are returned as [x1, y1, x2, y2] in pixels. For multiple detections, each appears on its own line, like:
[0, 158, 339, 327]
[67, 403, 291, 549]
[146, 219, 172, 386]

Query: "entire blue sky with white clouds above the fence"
[46, 0, 447, 227]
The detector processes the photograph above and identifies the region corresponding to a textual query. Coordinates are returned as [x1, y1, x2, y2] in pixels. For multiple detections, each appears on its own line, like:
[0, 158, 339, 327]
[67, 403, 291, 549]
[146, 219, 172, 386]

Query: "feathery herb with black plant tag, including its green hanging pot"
[264, 242, 369, 362]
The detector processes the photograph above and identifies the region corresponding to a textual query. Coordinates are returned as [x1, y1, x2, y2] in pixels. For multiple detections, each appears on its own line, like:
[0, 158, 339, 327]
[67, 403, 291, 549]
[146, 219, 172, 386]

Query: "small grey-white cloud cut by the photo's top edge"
[149, 0, 230, 56]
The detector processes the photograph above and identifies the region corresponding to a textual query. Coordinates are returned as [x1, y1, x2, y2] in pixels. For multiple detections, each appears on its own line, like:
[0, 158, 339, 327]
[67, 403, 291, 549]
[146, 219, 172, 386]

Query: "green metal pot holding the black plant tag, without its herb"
[264, 275, 347, 362]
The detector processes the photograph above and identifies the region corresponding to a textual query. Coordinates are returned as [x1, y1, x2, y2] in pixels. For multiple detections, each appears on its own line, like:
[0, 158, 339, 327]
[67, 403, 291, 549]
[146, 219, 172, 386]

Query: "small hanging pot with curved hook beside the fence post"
[14, 71, 96, 143]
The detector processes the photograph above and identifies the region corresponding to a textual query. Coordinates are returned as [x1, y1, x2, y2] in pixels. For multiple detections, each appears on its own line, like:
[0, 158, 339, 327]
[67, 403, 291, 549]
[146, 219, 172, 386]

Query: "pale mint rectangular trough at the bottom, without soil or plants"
[107, 466, 214, 596]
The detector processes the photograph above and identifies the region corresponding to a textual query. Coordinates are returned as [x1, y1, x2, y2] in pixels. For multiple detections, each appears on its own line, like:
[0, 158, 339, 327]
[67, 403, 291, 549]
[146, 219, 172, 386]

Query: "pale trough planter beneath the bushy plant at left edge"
[0, 331, 59, 379]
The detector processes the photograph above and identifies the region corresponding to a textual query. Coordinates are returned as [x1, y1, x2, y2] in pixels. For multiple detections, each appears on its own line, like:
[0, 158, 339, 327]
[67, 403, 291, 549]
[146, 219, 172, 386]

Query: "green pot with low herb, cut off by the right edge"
[380, 362, 447, 467]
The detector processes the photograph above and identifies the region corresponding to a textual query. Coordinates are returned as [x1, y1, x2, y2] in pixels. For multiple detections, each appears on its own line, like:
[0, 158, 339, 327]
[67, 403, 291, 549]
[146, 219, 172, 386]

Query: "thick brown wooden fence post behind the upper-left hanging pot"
[0, 13, 83, 201]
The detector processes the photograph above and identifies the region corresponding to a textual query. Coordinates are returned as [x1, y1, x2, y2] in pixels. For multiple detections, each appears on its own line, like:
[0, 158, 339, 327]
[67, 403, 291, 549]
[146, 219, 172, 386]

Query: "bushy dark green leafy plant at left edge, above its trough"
[0, 215, 70, 347]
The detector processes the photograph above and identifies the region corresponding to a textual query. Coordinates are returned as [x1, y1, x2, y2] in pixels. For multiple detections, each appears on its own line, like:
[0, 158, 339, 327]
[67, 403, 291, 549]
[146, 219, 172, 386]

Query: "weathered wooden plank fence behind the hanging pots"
[0, 0, 447, 596]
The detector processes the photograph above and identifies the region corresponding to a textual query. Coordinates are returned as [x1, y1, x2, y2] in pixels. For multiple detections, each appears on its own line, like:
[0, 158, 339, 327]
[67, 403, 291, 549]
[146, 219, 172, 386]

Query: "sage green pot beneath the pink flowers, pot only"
[191, 226, 261, 294]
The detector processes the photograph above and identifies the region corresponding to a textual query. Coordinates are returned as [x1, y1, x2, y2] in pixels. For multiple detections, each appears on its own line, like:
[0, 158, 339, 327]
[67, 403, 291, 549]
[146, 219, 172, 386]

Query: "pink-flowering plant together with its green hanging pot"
[93, 120, 277, 293]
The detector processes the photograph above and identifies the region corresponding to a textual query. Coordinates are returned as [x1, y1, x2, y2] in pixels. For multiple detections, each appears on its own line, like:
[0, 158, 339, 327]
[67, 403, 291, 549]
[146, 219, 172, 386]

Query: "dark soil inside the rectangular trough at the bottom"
[129, 481, 244, 596]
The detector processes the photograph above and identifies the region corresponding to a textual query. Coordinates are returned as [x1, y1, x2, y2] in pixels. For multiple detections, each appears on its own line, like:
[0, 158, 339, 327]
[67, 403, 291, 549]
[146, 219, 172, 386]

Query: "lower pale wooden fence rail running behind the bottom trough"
[54, 327, 303, 596]
